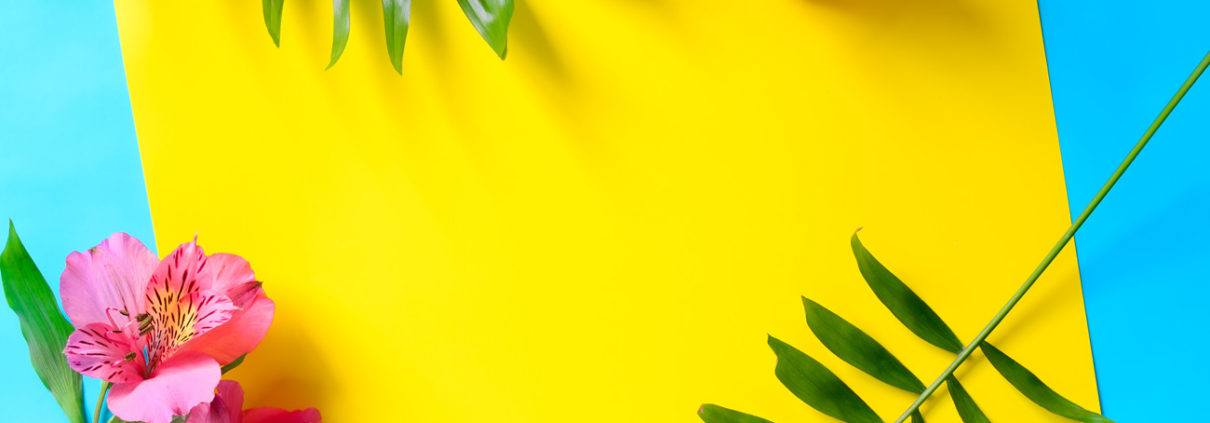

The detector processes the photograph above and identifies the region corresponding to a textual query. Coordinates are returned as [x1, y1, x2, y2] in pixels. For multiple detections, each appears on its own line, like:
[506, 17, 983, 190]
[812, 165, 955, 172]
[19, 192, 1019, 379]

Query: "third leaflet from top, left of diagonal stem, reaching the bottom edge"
[768, 336, 882, 423]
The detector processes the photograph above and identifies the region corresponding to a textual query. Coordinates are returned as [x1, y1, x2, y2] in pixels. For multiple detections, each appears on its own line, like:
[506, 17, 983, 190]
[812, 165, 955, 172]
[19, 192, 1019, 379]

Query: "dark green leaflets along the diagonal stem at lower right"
[703, 234, 1112, 423]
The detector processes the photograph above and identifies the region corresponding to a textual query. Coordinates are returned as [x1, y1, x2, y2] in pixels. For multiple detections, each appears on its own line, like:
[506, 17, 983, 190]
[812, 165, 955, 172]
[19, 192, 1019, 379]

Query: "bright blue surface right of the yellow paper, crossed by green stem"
[1039, 0, 1210, 422]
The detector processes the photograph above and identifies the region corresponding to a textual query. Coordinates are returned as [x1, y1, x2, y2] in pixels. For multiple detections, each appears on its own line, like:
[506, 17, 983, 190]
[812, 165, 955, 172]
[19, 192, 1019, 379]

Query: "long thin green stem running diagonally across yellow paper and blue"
[895, 52, 1210, 423]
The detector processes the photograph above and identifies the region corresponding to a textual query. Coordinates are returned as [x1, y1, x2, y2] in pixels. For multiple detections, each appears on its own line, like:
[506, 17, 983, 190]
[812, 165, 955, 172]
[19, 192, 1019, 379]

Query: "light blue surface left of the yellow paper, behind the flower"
[0, 0, 155, 422]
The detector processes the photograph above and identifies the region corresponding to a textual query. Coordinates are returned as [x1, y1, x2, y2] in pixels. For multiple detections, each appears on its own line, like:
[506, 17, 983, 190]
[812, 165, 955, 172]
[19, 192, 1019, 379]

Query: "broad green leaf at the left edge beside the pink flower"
[0, 220, 85, 423]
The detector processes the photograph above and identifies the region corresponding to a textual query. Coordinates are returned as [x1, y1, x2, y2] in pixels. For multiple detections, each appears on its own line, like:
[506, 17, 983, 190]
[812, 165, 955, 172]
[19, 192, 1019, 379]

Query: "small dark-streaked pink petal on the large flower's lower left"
[63, 323, 144, 383]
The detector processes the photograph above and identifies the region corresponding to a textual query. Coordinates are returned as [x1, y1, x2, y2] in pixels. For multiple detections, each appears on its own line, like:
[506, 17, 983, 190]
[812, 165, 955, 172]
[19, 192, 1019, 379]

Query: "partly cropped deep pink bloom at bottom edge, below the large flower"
[185, 381, 322, 423]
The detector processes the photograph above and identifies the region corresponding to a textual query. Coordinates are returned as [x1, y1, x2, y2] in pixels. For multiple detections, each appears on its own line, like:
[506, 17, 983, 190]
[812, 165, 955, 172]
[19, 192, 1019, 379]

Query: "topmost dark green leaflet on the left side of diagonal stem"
[852, 232, 962, 353]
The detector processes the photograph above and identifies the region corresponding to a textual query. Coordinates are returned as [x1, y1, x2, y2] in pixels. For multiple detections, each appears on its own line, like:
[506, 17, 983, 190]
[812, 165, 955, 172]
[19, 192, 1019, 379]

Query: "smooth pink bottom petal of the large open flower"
[109, 353, 221, 423]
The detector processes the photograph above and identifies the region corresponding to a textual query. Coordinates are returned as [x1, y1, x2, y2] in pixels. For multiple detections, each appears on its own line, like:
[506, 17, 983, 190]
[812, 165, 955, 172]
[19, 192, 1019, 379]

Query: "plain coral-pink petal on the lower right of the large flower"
[180, 292, 276, 364]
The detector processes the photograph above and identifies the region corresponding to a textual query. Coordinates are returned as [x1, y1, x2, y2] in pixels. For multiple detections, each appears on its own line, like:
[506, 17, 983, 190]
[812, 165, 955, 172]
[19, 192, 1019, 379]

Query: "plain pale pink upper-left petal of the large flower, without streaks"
[59, 232, 160, 328]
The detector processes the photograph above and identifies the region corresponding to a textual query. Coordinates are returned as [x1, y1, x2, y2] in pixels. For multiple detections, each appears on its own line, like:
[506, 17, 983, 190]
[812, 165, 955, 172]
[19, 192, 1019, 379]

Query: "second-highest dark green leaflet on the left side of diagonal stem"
[802, 297, 924, 394]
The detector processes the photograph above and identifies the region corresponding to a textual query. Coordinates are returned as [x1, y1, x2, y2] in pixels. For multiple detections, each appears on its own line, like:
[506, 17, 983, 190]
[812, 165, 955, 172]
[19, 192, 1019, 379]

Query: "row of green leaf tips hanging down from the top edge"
[261, 0, 513, 71]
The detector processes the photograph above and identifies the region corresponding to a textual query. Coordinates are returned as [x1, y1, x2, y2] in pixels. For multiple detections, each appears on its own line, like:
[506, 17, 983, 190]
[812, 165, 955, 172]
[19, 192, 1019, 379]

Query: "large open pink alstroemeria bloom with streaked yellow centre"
[59, 233, 273, 423]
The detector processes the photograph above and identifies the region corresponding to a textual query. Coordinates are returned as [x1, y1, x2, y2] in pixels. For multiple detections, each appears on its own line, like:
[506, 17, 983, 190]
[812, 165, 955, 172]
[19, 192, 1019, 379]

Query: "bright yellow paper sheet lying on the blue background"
[116, 0, 1096, 423]
